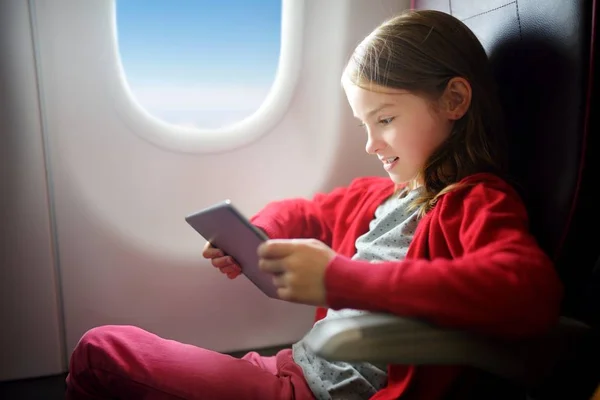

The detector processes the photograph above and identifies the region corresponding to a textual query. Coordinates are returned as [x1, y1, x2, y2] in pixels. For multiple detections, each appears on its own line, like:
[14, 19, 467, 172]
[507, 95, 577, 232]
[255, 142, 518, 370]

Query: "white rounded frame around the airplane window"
[111, 0, 305, 154]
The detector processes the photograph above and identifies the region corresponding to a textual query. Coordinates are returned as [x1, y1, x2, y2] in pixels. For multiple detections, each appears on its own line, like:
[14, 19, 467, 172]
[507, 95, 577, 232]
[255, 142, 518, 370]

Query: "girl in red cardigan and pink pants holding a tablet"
[67, 11, 562, 400]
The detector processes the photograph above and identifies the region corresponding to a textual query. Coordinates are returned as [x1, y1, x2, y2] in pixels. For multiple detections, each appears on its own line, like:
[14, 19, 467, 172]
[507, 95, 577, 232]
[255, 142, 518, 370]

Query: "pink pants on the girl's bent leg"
[66, 325, 314, 400]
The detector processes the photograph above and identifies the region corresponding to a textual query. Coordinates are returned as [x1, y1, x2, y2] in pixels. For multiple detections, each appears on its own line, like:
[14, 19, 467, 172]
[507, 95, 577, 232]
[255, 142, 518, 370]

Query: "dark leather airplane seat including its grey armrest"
[305, 0, 600, 400]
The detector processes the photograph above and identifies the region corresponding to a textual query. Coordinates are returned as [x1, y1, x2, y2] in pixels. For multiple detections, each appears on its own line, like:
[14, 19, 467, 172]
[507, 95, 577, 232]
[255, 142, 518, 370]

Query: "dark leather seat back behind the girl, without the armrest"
[412, 0, 600, 399]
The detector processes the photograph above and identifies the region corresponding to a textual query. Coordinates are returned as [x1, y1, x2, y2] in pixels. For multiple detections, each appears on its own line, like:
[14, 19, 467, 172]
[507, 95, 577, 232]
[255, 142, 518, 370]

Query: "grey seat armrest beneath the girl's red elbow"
[303, 313, 589, 384]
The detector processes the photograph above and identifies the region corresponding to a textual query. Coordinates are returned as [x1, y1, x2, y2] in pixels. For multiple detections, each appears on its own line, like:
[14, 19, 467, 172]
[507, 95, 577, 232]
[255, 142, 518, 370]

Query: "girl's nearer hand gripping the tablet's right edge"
[258, 239, 336, 307]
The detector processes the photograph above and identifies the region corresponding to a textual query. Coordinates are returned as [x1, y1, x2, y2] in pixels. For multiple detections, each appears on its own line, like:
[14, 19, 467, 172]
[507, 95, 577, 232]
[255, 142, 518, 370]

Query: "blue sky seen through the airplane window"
[116, 0, 281, 128]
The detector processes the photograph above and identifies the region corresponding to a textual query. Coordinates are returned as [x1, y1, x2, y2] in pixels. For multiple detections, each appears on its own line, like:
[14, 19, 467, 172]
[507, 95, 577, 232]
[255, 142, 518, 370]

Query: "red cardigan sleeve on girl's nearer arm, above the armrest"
[325, 184, 562, 338]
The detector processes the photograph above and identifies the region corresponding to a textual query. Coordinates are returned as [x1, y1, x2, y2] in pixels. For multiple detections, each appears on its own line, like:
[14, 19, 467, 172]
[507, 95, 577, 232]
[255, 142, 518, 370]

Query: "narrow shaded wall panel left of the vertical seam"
[0, 1, 66, 381]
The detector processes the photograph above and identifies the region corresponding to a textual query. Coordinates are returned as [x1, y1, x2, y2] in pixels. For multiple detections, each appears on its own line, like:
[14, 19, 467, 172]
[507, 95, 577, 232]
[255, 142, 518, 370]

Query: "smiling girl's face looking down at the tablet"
[342, 79, 453, 184]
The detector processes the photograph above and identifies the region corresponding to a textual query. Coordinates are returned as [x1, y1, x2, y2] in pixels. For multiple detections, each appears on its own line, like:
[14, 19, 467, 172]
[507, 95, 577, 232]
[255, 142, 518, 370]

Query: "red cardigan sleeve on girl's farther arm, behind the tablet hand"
[250, 183, 349, 246]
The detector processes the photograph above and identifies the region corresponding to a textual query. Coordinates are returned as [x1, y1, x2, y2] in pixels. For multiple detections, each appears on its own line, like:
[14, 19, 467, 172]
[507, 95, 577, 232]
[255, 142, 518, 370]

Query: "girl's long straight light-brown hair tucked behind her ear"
[344, 10, 506, 217]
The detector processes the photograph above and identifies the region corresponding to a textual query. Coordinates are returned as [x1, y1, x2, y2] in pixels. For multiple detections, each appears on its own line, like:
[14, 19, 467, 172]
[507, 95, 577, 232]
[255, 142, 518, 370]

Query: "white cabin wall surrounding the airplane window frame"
[0, 0, 409, 380]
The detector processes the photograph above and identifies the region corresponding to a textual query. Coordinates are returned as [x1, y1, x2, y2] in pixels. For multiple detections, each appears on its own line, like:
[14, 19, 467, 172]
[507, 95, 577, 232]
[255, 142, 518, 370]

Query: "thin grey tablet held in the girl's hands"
[185, 200, 279, 299]
